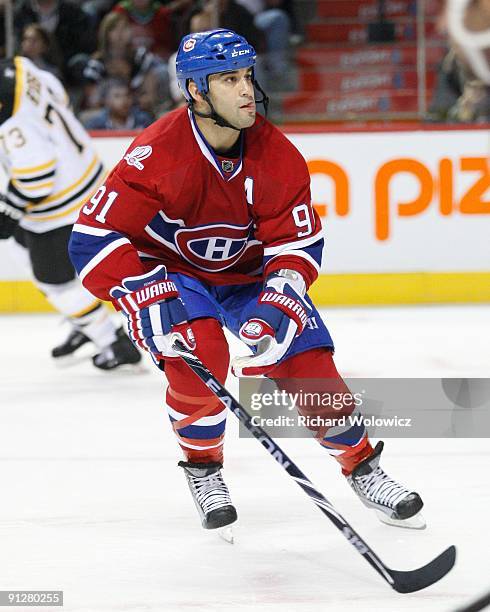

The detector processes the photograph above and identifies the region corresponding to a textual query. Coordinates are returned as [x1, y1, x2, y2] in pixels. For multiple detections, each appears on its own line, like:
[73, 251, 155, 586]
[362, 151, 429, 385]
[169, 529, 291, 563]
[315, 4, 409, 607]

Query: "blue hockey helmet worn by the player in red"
[175, 29, 257, 101]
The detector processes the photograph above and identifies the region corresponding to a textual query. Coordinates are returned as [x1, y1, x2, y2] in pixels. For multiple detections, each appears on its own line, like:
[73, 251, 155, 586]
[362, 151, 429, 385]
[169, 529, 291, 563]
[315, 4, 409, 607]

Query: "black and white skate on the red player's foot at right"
[347, 442, 425, 529]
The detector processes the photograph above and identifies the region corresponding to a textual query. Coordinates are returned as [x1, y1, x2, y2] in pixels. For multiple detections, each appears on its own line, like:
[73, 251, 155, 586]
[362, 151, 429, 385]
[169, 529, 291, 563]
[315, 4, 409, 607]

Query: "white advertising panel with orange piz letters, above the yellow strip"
[289, 130, 490, 273]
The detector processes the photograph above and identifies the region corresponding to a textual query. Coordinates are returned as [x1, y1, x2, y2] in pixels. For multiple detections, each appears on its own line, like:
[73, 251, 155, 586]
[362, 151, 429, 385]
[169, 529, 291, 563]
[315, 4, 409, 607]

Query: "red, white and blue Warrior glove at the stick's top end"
[110, 266, 195, 361]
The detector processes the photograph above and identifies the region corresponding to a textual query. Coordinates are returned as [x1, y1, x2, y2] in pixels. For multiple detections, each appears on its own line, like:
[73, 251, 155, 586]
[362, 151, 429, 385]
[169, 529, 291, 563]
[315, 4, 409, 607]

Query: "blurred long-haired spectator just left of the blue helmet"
[82, 12, 169, 113]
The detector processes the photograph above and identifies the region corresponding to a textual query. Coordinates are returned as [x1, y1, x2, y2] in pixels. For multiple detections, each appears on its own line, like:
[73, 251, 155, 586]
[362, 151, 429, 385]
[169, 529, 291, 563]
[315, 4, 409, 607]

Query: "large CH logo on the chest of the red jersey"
[174, 224, 252, 272]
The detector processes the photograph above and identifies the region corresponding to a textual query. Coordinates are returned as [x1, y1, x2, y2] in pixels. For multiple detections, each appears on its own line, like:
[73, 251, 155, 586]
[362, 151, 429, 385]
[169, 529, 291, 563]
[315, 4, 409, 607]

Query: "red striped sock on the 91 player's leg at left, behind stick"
[165, 319, 230, 463]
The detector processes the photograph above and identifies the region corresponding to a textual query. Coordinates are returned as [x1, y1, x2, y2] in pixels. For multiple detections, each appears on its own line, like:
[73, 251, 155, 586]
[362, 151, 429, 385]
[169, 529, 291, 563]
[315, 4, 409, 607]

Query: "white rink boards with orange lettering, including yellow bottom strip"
[0, 127, 490, 310]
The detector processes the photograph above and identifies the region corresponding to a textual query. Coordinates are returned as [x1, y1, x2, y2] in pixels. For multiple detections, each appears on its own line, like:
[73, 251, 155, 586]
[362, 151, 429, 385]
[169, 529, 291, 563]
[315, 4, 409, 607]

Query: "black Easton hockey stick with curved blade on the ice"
[172, 338, 456, 593]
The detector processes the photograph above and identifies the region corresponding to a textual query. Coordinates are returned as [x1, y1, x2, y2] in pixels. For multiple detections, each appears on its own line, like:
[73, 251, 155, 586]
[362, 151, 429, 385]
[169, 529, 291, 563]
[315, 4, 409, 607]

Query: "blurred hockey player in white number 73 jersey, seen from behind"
[0, 57, 141, 370]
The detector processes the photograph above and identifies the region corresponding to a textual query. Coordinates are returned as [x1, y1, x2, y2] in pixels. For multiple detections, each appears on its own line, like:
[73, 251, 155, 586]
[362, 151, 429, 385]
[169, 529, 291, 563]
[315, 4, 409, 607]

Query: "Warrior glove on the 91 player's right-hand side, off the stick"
[232, 270, 311, 376]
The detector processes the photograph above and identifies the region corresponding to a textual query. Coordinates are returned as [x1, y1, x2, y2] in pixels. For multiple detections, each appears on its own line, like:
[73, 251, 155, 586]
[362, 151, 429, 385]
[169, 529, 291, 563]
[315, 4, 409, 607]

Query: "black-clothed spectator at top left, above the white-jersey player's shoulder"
[14, 0, 95, 81]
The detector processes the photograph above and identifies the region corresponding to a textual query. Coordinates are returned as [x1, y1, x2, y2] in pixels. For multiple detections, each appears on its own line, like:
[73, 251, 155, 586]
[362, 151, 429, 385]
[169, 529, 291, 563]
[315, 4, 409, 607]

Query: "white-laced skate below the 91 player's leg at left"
[179, 461, 237, 532]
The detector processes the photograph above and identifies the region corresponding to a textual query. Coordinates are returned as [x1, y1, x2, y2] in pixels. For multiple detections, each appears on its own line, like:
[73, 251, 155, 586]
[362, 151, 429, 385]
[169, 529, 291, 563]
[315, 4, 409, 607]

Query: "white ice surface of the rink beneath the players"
[0, 306, 490, 612]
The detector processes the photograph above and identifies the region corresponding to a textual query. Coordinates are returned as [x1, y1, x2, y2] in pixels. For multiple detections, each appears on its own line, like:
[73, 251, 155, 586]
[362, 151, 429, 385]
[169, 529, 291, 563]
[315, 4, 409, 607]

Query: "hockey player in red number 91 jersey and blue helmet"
[70, 29, 422, 529]
